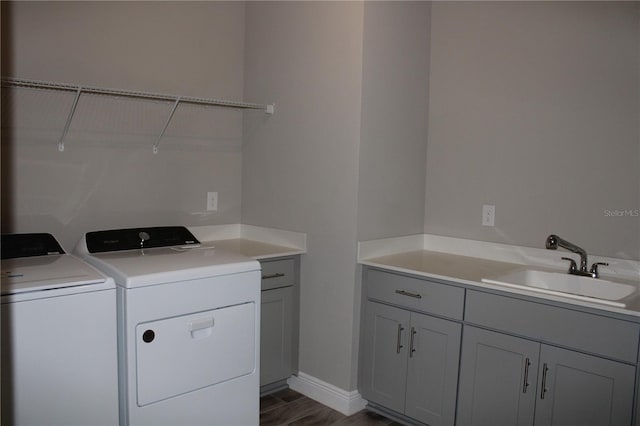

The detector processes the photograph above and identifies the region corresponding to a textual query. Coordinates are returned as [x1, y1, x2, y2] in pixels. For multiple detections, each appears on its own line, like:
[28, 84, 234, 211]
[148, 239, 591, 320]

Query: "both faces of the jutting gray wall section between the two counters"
[242, 2, 430, 390]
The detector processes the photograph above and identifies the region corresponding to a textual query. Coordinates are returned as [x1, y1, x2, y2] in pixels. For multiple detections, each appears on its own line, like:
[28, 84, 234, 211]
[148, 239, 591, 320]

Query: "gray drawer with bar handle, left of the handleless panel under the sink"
[365, 269, 464, 320]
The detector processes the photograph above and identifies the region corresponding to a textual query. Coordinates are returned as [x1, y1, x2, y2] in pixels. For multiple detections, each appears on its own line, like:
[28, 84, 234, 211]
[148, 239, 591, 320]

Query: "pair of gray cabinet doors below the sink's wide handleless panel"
[457, 326, 635, 426]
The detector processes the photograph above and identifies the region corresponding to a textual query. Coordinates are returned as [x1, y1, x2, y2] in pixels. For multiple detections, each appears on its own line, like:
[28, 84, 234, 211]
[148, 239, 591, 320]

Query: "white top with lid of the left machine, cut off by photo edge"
[0, 254, 114, 296]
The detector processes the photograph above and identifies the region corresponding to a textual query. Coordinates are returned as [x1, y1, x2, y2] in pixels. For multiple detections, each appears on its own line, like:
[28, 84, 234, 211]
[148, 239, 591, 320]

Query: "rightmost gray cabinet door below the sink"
[536, 345, 635, 426]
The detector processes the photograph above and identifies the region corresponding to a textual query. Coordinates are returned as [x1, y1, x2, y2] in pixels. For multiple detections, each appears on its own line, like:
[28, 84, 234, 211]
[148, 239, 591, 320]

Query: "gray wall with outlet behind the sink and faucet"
[424, 2, 640, 259]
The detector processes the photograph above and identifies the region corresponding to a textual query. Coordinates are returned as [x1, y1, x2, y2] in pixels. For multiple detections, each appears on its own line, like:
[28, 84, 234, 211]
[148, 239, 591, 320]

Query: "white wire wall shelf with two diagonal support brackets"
[1, 77, 275, 153]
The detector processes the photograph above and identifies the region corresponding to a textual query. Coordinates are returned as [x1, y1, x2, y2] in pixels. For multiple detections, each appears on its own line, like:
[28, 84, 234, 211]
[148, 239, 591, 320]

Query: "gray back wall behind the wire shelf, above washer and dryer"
[2, 2, 248, 249]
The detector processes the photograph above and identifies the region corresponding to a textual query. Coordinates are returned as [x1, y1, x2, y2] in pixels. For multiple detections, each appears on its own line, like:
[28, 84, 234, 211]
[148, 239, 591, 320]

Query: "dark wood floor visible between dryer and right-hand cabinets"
[260, 389, 400, 426]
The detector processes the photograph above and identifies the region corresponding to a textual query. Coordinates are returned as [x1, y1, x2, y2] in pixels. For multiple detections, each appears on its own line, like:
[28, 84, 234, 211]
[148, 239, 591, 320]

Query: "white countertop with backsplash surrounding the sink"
[359, 235, 640, 317]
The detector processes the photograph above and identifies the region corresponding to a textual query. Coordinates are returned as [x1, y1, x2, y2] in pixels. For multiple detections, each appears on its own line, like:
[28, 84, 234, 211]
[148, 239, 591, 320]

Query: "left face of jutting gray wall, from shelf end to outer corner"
[242, 2, 363, 390]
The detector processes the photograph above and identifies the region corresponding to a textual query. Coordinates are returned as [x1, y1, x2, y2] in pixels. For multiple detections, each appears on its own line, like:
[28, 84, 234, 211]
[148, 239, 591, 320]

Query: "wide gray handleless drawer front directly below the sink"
[465, 290, 640, 364]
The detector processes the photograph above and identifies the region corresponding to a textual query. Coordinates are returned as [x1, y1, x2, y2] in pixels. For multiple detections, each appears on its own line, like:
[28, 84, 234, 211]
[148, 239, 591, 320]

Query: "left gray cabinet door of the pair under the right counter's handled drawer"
[360, 302, 410, 413]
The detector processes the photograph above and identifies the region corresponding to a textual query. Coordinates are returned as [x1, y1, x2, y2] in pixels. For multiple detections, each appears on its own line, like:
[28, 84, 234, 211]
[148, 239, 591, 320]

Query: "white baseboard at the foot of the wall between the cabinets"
[287, 372, 367, 416]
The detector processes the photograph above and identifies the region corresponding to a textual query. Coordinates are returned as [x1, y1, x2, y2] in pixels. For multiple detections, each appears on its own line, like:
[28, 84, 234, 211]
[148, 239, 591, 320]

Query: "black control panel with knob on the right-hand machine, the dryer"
[85, 226, 200, 253]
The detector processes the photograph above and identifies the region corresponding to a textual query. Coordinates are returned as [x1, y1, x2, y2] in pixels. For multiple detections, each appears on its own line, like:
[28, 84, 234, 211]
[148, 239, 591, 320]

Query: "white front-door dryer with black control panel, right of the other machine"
[74, 226, 260, 426]
